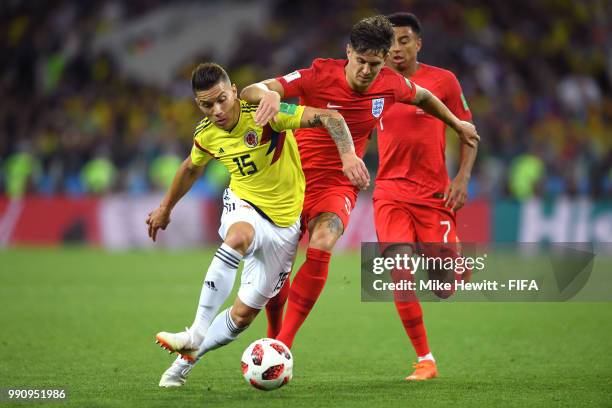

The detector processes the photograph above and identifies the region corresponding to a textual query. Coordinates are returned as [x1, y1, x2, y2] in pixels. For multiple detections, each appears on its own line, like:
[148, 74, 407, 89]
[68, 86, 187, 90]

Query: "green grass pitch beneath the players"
[0, 248, 612, 408]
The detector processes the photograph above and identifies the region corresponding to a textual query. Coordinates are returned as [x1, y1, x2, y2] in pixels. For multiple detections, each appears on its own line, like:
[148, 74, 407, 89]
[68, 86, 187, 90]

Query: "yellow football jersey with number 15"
[191, 100, 306, 227]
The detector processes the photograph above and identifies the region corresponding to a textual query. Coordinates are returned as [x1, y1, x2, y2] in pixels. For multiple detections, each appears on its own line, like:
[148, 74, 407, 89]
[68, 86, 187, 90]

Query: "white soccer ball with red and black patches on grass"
[240, 339, 293, 391]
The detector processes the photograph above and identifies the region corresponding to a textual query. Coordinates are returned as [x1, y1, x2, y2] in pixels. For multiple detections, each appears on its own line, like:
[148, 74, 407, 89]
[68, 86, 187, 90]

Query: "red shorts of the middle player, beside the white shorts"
[302, 186, 357, 231]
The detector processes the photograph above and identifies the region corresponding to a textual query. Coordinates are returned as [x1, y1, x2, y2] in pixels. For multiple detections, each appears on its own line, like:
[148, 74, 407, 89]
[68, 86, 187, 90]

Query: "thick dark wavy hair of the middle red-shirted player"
[350, 15, 393, 54]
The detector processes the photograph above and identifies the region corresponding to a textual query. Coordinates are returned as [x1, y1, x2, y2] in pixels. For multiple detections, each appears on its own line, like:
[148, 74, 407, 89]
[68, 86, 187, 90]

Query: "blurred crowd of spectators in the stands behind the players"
[0, 0, 612, 200]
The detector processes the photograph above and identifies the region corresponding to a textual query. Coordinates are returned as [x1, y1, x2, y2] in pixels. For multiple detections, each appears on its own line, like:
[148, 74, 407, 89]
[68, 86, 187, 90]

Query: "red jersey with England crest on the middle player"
[276, 59, 416, 191]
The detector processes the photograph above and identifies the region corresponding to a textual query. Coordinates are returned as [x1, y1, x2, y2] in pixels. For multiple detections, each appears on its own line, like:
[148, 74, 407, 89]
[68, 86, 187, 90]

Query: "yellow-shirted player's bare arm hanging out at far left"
[146, 157, 204, 241]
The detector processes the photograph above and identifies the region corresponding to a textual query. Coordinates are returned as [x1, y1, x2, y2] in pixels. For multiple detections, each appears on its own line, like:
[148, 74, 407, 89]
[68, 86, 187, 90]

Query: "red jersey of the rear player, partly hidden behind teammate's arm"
[374, 64, 472, 206]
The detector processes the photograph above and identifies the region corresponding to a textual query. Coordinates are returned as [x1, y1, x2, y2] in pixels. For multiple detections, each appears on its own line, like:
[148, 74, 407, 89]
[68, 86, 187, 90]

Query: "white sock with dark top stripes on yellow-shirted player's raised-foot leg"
[189, 243, 242, 343]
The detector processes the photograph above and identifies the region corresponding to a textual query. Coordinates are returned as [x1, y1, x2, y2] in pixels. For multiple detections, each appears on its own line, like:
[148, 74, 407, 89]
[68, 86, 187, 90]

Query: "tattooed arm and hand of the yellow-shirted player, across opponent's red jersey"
[300, 107, 370, 190]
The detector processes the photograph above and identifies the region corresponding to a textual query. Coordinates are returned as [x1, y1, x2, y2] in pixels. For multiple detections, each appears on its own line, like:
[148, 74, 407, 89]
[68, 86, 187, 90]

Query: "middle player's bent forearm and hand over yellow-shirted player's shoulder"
[240, 79, 285, 126]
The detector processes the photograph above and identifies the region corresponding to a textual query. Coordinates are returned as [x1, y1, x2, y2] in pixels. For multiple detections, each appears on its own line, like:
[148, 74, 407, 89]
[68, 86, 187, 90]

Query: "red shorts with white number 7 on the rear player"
[374, 199, 459, 243]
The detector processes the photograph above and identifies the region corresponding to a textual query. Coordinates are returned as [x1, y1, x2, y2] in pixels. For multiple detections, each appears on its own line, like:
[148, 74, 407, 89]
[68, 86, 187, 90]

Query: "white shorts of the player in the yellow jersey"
[219, 188, 300, 309]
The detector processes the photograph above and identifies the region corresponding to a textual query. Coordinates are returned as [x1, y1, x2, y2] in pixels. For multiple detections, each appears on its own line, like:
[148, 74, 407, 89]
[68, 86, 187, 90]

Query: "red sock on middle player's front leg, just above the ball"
[276, 248, 331, 348]
